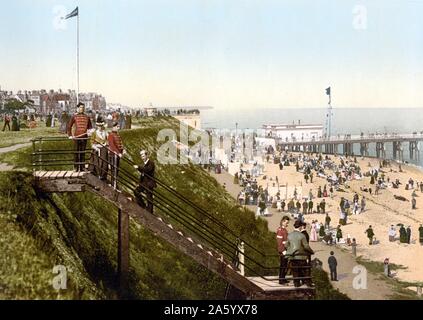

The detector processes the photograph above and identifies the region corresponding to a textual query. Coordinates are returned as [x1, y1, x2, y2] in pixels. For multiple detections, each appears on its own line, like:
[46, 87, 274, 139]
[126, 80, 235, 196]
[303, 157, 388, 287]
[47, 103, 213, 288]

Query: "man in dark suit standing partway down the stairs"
[134, 150, 157, 213]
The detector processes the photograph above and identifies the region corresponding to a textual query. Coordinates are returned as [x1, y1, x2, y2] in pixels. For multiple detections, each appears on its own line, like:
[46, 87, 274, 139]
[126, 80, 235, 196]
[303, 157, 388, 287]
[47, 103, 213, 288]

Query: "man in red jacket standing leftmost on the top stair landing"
[67, 102, 92, 171]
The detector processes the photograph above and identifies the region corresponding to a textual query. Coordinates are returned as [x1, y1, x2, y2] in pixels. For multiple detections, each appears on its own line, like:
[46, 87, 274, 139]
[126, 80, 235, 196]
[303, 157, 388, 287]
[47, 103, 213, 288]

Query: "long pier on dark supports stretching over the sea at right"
[275, 132, 423, 161]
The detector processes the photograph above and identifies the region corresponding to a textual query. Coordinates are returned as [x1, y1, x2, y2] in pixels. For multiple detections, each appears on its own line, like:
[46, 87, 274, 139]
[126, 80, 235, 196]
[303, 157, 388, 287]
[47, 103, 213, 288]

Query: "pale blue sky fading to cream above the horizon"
[0, 0, 423, 111]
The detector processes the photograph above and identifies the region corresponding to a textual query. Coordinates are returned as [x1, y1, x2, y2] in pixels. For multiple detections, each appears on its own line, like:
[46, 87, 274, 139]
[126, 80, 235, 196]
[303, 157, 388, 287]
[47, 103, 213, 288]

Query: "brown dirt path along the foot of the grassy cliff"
[211, 172, 393, 300]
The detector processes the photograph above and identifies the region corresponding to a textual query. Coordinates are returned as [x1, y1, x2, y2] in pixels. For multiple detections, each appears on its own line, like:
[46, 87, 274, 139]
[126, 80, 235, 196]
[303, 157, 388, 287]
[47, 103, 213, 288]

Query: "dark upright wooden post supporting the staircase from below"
[118, 208, 129, 298]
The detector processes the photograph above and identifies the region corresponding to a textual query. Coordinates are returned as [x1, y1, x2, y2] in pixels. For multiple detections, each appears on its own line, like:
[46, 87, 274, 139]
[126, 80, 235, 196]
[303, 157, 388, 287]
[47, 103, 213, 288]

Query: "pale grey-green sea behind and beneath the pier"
[201, 108, 423, 167]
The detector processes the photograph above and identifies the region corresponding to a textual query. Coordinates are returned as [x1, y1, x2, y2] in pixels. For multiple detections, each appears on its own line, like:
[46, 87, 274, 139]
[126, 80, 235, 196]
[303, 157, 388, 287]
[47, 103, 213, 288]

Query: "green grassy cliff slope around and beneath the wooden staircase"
[0, 118, 348, 299]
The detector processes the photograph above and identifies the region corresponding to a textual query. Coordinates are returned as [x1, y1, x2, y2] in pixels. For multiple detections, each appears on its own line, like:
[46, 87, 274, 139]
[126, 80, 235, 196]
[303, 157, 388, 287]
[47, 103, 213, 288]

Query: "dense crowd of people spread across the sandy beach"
[230, 141, 423, 279]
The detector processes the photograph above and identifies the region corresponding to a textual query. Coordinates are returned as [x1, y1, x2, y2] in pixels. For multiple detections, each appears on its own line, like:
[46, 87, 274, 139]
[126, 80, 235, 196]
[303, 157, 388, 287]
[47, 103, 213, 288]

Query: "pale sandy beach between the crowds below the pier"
[257, 156, 423, 282]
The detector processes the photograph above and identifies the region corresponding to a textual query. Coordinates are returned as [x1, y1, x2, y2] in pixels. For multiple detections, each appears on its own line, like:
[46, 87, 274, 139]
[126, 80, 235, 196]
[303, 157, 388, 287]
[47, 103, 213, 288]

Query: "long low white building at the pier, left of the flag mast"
[263, 123, 323, 141]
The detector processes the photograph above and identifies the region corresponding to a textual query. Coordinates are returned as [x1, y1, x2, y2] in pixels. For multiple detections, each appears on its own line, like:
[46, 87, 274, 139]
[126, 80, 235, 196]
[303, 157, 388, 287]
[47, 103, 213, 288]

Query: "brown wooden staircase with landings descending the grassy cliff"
[34, 171, 315, 300]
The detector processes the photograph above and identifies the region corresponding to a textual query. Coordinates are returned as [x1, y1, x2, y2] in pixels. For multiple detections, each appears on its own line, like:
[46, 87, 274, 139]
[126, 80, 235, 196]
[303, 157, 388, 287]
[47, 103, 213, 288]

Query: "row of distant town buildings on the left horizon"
[0, 89, 106, 114]
